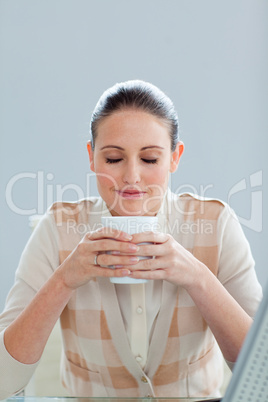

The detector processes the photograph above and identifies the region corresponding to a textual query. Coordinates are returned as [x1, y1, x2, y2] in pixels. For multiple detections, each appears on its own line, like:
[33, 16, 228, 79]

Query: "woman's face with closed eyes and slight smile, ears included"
[88, 110, 183, 215]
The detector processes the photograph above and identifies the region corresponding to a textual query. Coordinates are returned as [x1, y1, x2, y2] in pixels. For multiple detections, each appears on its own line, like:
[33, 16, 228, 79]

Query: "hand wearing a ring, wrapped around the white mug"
[56, 227, 139, 289]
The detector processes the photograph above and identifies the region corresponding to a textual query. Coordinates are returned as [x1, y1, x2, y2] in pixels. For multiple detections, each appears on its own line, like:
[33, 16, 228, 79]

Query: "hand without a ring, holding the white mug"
[126, 232, 206, 288]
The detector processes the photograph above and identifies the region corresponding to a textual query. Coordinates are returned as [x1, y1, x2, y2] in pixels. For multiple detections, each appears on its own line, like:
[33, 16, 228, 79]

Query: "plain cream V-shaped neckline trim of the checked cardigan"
[98, 189, 178, 378]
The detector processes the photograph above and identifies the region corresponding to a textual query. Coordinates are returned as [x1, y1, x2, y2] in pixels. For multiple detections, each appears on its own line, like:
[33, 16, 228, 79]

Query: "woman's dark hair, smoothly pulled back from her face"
[90, 80, 179, 151]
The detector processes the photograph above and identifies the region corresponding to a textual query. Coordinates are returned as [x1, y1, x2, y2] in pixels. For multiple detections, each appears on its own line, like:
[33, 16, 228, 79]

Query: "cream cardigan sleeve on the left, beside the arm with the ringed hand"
[0, 213, 59, 399]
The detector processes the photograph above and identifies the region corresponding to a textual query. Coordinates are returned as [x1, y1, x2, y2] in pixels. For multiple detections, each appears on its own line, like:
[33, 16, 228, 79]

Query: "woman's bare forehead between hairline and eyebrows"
[96, 110, 170, 146]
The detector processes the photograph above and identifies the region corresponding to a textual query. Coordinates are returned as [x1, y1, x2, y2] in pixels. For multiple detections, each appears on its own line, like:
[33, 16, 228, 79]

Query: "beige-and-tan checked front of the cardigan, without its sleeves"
[53, 192, 258, 397]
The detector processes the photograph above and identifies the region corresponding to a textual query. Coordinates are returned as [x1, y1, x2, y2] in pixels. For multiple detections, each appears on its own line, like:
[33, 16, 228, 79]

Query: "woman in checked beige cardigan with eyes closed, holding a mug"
[0, 81, 261, 397]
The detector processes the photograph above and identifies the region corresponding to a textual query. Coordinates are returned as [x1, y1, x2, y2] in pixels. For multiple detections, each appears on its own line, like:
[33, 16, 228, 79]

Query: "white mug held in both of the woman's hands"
[101, 216, 158, 284]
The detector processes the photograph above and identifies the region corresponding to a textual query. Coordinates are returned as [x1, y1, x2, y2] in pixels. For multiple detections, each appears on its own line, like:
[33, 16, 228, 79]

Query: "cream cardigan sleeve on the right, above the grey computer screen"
[218, 206, 262, 318]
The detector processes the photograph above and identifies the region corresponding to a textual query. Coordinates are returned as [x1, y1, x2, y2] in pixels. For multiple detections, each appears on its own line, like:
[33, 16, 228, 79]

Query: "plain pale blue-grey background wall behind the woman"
[0, 0, 268, 309]
